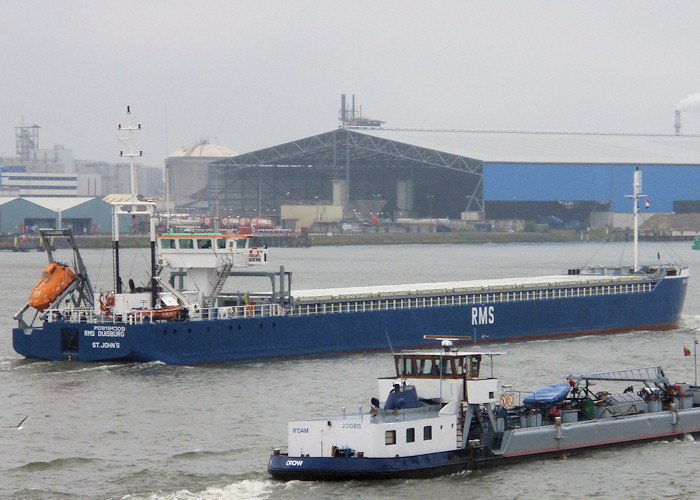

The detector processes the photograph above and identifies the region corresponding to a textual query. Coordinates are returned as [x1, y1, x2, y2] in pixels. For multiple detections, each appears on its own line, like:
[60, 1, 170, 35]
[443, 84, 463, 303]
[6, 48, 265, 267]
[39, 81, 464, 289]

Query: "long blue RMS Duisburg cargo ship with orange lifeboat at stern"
[8, 114, 689, 365]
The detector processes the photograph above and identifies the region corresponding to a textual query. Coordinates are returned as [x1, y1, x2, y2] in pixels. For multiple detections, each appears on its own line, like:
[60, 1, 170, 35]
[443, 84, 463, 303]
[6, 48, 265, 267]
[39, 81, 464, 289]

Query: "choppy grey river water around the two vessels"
[0, 242, 700, 500]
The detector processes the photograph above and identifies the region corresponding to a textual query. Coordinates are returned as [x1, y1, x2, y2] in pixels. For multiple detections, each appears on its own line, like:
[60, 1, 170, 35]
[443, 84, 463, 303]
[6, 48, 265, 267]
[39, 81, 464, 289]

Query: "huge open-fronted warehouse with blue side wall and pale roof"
[207, 127, 700, 230]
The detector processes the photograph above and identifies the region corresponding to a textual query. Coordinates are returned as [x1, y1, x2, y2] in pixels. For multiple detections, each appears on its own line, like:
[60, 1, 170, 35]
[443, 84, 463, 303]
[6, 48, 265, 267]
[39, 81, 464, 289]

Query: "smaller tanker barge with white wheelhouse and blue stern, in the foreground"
[267, 337, 700, 480]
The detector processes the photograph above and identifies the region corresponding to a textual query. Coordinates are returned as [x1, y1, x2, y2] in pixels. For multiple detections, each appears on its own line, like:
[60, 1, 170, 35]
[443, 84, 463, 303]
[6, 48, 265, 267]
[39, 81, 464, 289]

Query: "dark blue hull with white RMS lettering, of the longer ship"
[13, 275, 688, 365]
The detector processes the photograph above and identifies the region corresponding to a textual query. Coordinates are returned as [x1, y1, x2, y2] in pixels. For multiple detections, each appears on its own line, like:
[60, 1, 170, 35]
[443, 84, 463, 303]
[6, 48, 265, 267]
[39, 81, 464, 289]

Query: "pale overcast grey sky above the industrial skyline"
[0, 0, 700, 165]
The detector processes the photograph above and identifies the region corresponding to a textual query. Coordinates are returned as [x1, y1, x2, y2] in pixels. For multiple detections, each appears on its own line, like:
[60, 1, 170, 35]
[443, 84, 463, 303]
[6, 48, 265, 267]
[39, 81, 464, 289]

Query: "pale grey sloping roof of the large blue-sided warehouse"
[349, 128, 700, 165]
